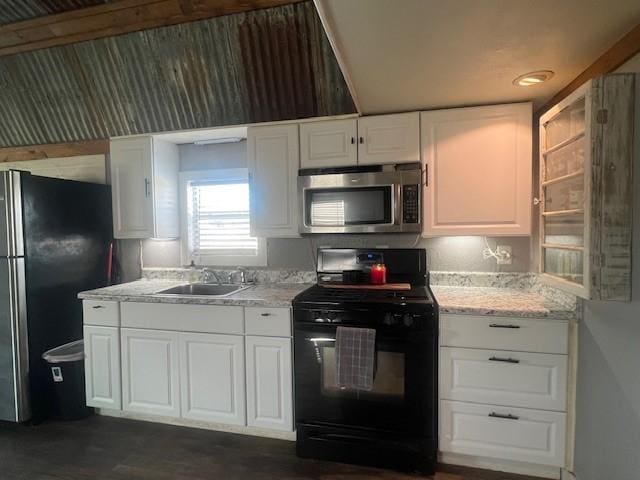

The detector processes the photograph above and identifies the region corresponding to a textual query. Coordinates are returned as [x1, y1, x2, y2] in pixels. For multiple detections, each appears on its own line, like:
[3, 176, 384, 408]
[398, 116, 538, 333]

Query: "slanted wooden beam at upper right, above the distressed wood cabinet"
[536, 25, 640, 117]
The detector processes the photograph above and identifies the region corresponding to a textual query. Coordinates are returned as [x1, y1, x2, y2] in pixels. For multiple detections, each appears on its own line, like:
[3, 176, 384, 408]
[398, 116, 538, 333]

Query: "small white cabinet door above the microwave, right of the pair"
[358, 112, 420, 165]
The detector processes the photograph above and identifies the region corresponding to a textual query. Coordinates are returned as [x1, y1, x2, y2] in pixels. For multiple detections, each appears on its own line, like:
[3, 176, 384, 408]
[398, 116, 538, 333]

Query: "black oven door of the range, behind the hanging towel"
[294, 323, 437, 437]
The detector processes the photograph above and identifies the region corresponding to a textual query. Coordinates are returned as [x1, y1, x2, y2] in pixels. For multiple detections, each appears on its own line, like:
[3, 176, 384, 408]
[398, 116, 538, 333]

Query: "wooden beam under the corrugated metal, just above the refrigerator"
[0, 140, 109, 163]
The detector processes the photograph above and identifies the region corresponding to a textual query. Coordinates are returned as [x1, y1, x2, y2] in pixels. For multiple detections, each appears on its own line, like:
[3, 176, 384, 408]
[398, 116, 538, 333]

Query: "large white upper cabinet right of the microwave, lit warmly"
[421, 103, 532, 236]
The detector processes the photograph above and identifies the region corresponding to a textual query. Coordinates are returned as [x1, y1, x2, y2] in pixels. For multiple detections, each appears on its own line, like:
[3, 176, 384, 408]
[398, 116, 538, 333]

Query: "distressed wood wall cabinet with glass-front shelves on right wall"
[539, 74, 636, 301]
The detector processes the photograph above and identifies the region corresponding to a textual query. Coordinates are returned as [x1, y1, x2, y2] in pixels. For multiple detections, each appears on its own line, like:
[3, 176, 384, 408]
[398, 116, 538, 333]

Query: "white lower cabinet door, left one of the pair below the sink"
[121, 328, 180, 417]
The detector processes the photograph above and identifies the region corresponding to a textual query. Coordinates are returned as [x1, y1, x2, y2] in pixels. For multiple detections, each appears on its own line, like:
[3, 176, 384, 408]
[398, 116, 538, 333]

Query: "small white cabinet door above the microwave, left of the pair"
[300, 119, 358, 168]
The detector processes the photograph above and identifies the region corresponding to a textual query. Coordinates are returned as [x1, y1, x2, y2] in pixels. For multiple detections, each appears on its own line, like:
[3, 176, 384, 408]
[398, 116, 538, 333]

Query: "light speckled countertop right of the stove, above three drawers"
[431, 285, 577, 320]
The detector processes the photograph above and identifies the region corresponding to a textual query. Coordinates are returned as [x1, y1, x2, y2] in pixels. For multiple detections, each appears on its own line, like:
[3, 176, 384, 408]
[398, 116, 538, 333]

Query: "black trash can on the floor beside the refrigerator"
[42, 340, 93, 420]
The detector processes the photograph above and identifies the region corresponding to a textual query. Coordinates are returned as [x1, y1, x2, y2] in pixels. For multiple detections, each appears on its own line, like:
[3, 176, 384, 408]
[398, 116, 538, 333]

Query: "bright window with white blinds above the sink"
[183, 169, 262, 264]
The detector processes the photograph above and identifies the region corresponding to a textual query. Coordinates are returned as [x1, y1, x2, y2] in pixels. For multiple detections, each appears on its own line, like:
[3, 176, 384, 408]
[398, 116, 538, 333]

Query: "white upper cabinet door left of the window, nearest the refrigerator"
[110, 137, 154, 238]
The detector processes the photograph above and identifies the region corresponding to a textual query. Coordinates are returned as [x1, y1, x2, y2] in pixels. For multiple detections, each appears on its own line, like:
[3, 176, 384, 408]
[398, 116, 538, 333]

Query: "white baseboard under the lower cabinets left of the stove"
[96, 408, 296, 441]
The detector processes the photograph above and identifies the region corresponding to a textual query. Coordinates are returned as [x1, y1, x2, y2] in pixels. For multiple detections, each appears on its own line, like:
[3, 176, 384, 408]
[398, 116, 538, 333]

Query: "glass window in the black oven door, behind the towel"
[318, 346, 405, 401]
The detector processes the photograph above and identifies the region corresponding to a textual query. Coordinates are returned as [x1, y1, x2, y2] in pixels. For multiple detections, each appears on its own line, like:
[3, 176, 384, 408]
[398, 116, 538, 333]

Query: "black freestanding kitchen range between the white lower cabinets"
[293, 249, 438, 474]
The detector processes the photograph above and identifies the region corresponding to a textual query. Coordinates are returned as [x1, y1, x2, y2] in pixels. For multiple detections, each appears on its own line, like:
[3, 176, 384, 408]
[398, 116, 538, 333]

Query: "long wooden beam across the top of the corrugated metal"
[0, 0, 303, 57]
